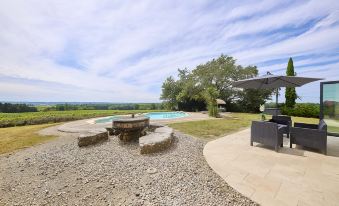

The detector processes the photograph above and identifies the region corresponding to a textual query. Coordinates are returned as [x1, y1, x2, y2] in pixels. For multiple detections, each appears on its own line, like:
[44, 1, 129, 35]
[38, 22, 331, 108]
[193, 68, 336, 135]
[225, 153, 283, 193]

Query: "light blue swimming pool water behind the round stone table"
[95, 112, 188, 123]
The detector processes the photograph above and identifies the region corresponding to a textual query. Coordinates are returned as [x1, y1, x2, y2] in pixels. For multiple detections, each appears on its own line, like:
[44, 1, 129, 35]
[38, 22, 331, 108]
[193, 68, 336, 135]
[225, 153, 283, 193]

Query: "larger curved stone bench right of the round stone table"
[139, 127, 173, 154]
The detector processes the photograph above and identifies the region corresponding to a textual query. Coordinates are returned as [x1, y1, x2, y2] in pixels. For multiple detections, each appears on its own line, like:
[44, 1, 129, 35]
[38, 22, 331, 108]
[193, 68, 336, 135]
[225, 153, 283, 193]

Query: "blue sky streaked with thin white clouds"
[0, 0, 339, 102]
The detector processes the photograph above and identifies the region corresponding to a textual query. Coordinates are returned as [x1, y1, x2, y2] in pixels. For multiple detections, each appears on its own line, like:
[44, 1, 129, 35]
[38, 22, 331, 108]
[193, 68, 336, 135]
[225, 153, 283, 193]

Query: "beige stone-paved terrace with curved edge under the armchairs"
[204, 129, 339, 206]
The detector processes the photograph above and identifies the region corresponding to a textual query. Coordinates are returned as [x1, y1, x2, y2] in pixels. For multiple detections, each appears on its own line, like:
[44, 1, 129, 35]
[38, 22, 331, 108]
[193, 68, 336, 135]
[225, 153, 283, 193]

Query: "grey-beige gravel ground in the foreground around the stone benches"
[0, 126, 256, 206]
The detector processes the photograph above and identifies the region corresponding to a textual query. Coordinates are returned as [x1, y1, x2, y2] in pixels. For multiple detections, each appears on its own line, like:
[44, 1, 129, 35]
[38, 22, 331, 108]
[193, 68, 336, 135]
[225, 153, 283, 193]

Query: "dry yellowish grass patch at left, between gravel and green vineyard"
[0, 124, 56, 154]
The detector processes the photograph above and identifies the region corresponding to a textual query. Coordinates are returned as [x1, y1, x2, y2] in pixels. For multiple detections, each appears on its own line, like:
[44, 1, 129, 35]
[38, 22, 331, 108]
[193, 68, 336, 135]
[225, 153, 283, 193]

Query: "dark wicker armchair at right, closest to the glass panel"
[290, 120, 327, 155]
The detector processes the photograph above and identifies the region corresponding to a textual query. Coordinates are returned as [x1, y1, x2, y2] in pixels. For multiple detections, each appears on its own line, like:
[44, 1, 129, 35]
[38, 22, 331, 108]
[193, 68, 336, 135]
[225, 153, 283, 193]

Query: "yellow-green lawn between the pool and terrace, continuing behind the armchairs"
[169, 113, 319, 140]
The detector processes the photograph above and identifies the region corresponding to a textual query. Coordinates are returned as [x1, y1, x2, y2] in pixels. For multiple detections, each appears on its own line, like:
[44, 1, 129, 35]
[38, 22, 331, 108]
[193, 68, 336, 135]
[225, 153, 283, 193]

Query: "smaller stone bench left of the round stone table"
[78, 130, 108, 147]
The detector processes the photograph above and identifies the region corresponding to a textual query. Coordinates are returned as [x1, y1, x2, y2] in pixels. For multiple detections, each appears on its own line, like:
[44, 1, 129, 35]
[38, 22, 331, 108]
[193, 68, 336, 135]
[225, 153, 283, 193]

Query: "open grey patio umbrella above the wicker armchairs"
[232, 73, 322, 106]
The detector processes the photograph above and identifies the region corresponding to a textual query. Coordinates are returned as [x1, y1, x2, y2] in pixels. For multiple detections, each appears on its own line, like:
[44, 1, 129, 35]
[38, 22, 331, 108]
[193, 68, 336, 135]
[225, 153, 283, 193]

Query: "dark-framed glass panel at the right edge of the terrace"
[320, 81, 339, 135]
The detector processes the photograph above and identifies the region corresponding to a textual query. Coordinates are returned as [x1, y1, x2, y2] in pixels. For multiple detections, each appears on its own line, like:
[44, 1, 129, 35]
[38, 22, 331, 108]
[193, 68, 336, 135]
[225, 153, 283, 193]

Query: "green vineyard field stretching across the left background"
[0, 110, 165, 128]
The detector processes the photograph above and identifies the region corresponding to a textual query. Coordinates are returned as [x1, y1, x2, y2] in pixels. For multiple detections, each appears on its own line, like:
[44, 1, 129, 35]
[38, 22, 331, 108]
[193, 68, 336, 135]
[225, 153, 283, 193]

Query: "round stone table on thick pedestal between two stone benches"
[113, 115, 149, 142]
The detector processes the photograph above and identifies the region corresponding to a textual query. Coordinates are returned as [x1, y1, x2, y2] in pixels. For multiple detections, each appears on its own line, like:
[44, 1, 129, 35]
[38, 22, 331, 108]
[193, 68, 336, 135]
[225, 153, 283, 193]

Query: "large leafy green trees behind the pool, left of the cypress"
[160, 55, 272, 116]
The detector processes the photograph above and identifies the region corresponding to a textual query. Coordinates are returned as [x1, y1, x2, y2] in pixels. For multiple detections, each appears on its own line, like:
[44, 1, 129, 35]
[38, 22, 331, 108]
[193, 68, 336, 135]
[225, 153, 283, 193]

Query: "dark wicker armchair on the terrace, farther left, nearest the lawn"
[251, 121, 283, 152]
